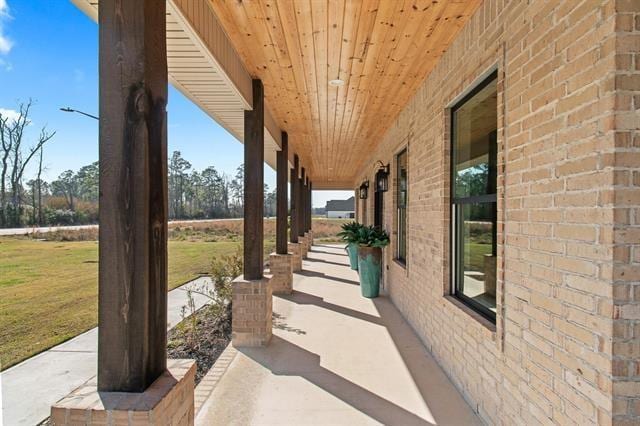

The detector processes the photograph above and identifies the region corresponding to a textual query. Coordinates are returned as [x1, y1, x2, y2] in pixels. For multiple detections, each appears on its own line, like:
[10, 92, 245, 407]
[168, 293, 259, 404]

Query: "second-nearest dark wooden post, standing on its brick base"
[244, 79, 264, 280]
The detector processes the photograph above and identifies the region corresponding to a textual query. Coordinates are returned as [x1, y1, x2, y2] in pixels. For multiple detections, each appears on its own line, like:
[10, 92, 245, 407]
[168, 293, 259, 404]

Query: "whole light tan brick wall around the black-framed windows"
[356, 0, 640, 425]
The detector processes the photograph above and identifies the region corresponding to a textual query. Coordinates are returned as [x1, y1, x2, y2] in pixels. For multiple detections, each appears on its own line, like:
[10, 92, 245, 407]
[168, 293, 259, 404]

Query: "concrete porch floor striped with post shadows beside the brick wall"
[196, 246, 481, 426]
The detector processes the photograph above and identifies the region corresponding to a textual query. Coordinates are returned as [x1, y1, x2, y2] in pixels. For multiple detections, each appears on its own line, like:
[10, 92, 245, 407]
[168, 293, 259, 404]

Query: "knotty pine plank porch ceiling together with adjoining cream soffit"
[71, 0, 482, 189]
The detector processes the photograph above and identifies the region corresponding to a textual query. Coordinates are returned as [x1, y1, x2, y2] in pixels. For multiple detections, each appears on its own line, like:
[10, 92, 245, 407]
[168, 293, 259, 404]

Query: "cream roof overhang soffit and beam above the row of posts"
[71, 0, 292, 170]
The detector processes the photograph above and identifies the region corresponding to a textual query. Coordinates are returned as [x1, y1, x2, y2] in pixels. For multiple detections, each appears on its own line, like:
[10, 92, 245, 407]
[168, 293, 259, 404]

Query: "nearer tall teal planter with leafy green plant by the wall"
[356, 226, 389, 298]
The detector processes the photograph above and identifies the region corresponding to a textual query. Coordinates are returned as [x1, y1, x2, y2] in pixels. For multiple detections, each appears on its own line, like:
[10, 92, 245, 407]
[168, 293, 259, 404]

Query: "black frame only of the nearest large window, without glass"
[449, 69, 498, 324]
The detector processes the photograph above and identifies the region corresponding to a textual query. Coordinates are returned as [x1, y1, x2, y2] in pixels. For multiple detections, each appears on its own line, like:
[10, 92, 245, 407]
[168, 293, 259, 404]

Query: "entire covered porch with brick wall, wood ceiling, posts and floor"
[48, 0, 640, 425]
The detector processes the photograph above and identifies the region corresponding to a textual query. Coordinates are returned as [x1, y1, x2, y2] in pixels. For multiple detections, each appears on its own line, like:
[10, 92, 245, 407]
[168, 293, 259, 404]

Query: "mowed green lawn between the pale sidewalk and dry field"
[0, 237, 240, 370]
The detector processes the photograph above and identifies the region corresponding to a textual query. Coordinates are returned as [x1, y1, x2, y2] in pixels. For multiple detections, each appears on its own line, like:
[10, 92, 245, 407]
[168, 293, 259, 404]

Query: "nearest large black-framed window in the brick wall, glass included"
[451, 73, 498, 322]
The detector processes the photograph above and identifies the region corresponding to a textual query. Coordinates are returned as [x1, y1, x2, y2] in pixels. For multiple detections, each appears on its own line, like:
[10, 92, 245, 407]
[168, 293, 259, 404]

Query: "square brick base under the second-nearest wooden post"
[231, 275, 273, 347]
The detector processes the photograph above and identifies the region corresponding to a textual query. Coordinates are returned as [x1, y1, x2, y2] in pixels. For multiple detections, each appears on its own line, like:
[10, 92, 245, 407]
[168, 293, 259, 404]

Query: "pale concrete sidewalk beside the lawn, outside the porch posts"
[0, 277, 211, 426]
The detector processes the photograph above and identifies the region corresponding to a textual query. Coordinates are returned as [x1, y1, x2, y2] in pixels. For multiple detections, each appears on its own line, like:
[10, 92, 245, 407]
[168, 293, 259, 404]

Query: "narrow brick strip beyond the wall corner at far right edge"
[607, 0, 640, 425]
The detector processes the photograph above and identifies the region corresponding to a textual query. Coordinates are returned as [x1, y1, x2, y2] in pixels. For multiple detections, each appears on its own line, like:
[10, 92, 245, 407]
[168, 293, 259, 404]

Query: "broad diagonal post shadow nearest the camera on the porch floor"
[239, 336, 433, 425]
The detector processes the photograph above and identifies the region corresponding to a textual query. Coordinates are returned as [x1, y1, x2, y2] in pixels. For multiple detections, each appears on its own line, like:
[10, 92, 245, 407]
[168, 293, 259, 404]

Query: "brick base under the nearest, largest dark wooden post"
[51, 359, 196, 426]
